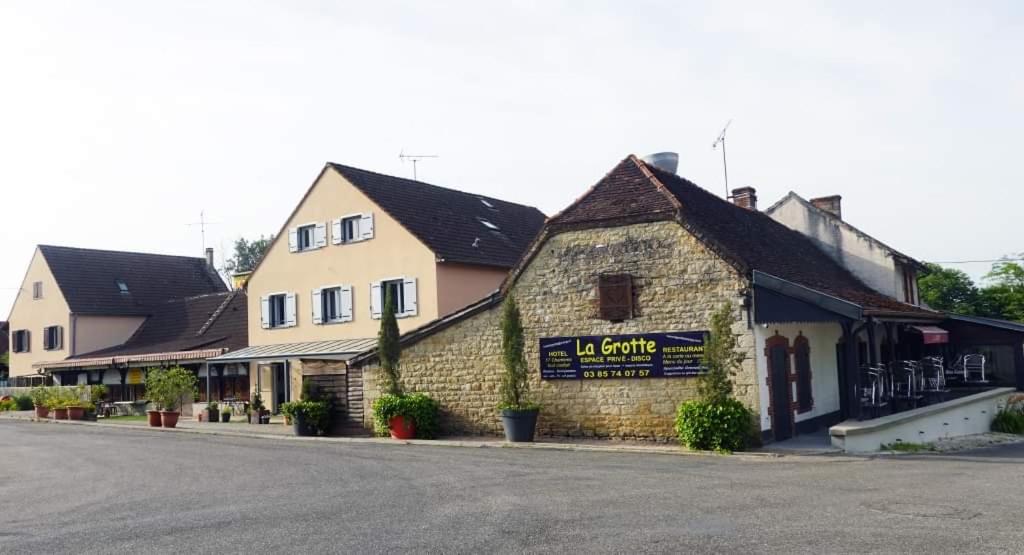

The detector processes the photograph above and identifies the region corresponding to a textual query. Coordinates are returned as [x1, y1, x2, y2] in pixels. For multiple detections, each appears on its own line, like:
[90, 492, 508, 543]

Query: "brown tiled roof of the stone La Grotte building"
[550, 156, 937, 316]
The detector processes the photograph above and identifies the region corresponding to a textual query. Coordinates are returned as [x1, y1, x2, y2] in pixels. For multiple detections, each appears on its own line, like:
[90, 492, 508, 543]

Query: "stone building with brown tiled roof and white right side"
[349, 156, 942, 439]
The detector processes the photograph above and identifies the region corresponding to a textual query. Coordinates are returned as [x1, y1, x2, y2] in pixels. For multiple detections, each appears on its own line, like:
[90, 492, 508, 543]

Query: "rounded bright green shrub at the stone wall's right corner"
[676, 398, 754, 452]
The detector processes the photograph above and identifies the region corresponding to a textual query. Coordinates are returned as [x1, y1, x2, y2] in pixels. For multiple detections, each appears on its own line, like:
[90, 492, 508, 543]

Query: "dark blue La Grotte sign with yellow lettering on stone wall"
[541, 332, 708, 380]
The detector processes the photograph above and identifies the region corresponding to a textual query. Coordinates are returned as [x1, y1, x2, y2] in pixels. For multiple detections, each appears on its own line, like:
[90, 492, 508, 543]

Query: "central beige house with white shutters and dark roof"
[212, 164, 545, 417]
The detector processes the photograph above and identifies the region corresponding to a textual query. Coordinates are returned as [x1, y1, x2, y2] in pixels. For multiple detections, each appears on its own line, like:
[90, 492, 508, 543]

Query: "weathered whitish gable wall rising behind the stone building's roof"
[767, 197, 916, 301]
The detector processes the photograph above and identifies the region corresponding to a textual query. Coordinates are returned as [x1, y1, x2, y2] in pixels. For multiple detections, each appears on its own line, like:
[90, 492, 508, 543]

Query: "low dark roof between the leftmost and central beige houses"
[70, 290, 249, 359]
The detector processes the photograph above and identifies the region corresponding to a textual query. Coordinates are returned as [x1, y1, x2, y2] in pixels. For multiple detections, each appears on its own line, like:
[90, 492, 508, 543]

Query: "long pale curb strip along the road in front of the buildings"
[2, 416, 803, 461]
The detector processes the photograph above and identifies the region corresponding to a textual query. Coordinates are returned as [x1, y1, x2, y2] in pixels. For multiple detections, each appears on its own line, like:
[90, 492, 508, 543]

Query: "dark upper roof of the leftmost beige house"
[39, 245, 227, 315]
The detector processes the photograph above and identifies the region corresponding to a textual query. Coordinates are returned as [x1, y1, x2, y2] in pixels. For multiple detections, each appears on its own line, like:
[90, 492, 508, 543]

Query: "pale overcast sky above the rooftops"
[0, 0, 1024, 317]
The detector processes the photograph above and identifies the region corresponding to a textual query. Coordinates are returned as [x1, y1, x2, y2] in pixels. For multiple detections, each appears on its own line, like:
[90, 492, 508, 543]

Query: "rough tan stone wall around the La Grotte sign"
[364, 222, 759, 439]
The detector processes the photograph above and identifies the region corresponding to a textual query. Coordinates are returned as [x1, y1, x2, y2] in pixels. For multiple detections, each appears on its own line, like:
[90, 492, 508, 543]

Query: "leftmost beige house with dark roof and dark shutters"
[8, 245, 226, 384]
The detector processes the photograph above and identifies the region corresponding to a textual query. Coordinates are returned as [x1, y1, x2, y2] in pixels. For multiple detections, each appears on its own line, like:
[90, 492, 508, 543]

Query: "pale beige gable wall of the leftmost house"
[8, 249, 72, 378]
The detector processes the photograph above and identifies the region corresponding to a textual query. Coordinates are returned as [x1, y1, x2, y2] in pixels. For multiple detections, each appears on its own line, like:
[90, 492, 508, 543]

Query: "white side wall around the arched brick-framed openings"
[754, 323, 843, 430]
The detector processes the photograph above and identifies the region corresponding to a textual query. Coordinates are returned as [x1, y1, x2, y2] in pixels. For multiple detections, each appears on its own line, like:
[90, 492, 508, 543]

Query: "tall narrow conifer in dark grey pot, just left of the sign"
[498, 295, 541, 441]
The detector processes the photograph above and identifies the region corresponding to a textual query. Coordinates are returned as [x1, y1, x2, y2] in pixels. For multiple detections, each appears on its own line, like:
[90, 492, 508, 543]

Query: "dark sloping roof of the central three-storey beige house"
[329, 164, 545, 268]
